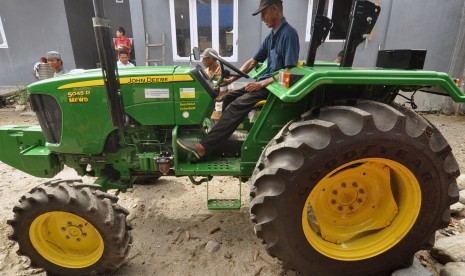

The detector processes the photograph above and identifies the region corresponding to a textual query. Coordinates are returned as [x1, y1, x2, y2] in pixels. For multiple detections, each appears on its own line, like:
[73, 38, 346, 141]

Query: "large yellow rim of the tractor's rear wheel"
[302, 158, 421, 261]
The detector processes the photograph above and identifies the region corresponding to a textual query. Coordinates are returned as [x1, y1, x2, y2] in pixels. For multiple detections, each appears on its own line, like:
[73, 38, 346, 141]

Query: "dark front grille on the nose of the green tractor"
[29, 94, 63, 144]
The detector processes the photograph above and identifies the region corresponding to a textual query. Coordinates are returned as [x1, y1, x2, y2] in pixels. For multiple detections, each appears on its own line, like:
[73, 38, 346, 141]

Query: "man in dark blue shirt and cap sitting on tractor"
[177, 0, 299, 158]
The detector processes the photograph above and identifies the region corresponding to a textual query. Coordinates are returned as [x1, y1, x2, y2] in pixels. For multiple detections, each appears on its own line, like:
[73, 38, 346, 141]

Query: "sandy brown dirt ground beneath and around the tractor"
[0, 108, 465, 275]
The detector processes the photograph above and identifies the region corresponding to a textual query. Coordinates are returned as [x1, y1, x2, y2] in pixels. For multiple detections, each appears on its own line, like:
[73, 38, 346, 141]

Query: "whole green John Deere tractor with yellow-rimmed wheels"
[0, 0, 465, 275]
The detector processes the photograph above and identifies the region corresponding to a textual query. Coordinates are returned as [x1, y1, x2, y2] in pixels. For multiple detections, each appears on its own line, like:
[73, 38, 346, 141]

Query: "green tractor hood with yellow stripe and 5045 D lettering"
[28, 66, 213, 154]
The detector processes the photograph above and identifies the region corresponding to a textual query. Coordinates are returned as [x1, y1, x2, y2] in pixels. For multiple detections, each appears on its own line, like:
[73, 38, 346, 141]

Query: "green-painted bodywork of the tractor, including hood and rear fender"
[0, 62, 465, 193]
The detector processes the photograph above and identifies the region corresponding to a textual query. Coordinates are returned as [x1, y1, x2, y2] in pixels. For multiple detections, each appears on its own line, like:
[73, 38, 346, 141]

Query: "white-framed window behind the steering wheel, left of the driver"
[170, 0, 238, 61]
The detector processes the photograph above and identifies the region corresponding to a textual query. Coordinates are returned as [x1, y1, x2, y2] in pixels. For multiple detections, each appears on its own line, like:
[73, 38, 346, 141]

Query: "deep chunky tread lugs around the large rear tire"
[250, 100, 459, 275]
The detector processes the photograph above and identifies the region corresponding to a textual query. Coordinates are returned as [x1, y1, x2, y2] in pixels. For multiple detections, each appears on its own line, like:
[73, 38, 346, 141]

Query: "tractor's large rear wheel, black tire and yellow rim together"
[251, 101, 459, 275]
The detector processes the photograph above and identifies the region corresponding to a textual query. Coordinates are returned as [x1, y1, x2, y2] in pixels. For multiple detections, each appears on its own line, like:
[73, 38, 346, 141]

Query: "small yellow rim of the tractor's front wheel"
[29, 212, 104, 268]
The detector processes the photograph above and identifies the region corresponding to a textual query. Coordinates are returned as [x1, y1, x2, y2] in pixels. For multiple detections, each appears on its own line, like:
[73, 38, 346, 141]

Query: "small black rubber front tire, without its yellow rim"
[8, 181, 132, 275]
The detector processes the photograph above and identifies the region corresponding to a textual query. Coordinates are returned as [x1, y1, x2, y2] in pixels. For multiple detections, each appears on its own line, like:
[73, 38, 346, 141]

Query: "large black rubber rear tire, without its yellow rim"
[250, 100, 459, 276]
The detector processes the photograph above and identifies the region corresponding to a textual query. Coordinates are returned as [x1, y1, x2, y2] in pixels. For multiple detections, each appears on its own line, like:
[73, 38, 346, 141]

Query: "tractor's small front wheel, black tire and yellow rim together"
[8, 181, 132, 275]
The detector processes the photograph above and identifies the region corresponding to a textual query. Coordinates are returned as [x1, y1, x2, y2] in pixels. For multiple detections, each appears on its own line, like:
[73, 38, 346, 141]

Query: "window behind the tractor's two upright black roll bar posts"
[305, 0, 352, 42]
